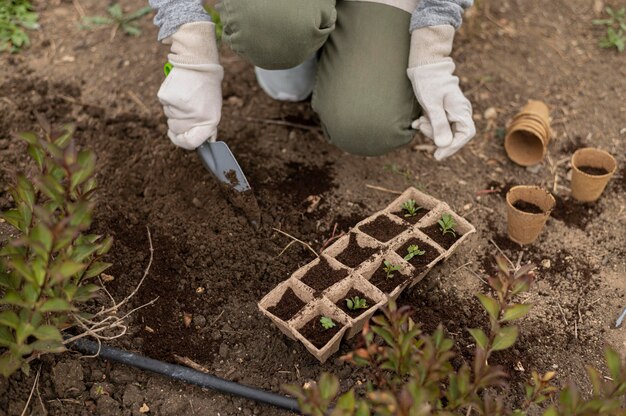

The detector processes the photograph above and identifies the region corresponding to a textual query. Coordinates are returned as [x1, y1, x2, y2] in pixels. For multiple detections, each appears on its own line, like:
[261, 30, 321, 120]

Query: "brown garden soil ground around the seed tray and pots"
[0, 0, 626, 416]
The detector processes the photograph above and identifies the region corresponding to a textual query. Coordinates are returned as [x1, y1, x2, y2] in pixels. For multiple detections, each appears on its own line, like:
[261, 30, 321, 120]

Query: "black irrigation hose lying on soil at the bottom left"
[71, 339, 300, 412]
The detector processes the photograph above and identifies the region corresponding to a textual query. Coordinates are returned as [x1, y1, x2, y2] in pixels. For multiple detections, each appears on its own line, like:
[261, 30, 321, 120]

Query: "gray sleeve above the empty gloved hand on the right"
[410, 0, 474, 32]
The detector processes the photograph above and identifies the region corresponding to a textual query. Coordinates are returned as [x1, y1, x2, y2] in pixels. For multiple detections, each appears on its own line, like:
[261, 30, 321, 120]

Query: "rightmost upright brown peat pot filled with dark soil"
[571, 147, 617, 202]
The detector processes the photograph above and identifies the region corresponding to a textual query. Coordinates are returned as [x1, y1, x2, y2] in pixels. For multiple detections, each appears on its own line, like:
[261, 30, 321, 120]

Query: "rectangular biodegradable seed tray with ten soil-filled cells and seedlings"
[259, 188, 476, 363]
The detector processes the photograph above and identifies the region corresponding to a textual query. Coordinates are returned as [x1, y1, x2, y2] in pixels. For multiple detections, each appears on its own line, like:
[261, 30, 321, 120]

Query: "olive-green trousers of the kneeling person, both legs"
[217, 0, 420, 156]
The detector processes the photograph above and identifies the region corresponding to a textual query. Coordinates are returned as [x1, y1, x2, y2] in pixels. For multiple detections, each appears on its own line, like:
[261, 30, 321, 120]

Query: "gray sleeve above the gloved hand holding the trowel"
[149, 0, 211, 40]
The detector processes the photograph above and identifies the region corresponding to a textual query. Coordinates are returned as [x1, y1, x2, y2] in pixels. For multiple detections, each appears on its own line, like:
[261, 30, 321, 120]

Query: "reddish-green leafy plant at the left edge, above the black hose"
[0, 119, 113, 377]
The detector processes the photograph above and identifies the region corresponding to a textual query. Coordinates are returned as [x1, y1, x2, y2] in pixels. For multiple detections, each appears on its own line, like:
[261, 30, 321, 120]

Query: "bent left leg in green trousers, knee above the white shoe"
[217, 0, 337, 69]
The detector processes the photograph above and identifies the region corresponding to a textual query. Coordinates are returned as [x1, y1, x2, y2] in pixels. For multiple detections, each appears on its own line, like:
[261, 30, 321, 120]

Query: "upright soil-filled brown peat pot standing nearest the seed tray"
[506, 185, 556, 244]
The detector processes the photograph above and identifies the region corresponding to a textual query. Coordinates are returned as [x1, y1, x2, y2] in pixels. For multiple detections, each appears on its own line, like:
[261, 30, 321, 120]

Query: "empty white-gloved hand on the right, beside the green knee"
[407, 25, 476, 160]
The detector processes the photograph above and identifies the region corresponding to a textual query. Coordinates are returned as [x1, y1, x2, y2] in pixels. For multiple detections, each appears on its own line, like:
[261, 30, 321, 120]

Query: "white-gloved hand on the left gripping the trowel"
[158, 22, 224, 150]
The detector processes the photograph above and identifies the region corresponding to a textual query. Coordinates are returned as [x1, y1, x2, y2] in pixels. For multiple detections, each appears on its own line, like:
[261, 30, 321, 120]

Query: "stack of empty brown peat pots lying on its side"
[504, 100, 551, 166]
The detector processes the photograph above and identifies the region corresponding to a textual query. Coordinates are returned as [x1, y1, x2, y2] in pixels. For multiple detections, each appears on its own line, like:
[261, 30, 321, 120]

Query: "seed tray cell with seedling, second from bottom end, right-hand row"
[326, 275, 387, 338]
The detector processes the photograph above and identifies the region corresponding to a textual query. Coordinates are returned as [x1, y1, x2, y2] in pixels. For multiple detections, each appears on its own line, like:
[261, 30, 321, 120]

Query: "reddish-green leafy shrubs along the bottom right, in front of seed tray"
[284, 257, 626, 416]
